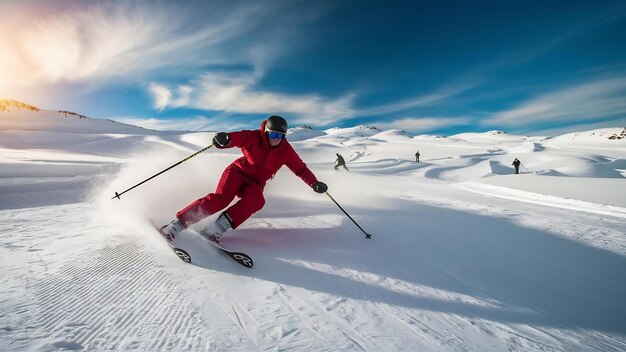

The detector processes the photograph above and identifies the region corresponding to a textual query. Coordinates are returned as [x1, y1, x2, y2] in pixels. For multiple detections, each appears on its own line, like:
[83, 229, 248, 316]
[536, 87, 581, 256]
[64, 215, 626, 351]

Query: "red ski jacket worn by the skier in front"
[218, 120, 317, 186]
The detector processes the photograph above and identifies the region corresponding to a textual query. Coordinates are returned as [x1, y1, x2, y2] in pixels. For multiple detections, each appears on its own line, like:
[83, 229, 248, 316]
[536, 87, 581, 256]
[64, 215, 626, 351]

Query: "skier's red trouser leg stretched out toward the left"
[176, 166, 244, 227]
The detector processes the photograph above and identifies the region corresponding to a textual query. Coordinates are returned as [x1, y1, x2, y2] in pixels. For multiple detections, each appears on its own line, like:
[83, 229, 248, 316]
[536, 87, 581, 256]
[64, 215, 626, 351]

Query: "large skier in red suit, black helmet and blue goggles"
[160, 116, 328, 243]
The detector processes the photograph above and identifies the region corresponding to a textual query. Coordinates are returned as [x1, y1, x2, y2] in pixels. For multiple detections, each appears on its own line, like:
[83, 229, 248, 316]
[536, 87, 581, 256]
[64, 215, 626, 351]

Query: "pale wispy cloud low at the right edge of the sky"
[483, 76, 626, 127]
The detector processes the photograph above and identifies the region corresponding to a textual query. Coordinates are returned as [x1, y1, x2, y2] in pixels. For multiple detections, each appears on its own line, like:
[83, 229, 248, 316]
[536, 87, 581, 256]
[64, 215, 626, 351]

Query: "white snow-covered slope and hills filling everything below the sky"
[0, 102, 626, 351]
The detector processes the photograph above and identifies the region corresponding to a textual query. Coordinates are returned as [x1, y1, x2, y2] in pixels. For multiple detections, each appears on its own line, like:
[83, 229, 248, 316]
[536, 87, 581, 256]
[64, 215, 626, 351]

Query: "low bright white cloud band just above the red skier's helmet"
[149, 71, 354, 125]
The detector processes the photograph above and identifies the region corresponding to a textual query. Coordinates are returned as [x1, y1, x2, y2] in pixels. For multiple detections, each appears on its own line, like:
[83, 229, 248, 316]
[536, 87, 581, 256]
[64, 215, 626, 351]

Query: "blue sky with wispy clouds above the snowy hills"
[0, 0, 626, 135]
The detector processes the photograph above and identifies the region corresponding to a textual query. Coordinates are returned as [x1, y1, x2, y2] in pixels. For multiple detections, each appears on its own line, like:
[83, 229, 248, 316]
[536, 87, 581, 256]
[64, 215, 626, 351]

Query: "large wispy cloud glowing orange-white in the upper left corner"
[0, 1, 264, 84]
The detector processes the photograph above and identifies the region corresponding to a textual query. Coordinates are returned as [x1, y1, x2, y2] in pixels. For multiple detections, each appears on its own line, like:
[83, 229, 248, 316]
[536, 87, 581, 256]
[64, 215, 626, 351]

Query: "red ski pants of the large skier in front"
[176, 165, 265, 229]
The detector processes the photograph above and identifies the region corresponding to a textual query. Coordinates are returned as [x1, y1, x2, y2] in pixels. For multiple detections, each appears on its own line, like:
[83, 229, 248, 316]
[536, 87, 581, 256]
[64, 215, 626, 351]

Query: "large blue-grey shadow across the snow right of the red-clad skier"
[184, 201, 626, 333]
